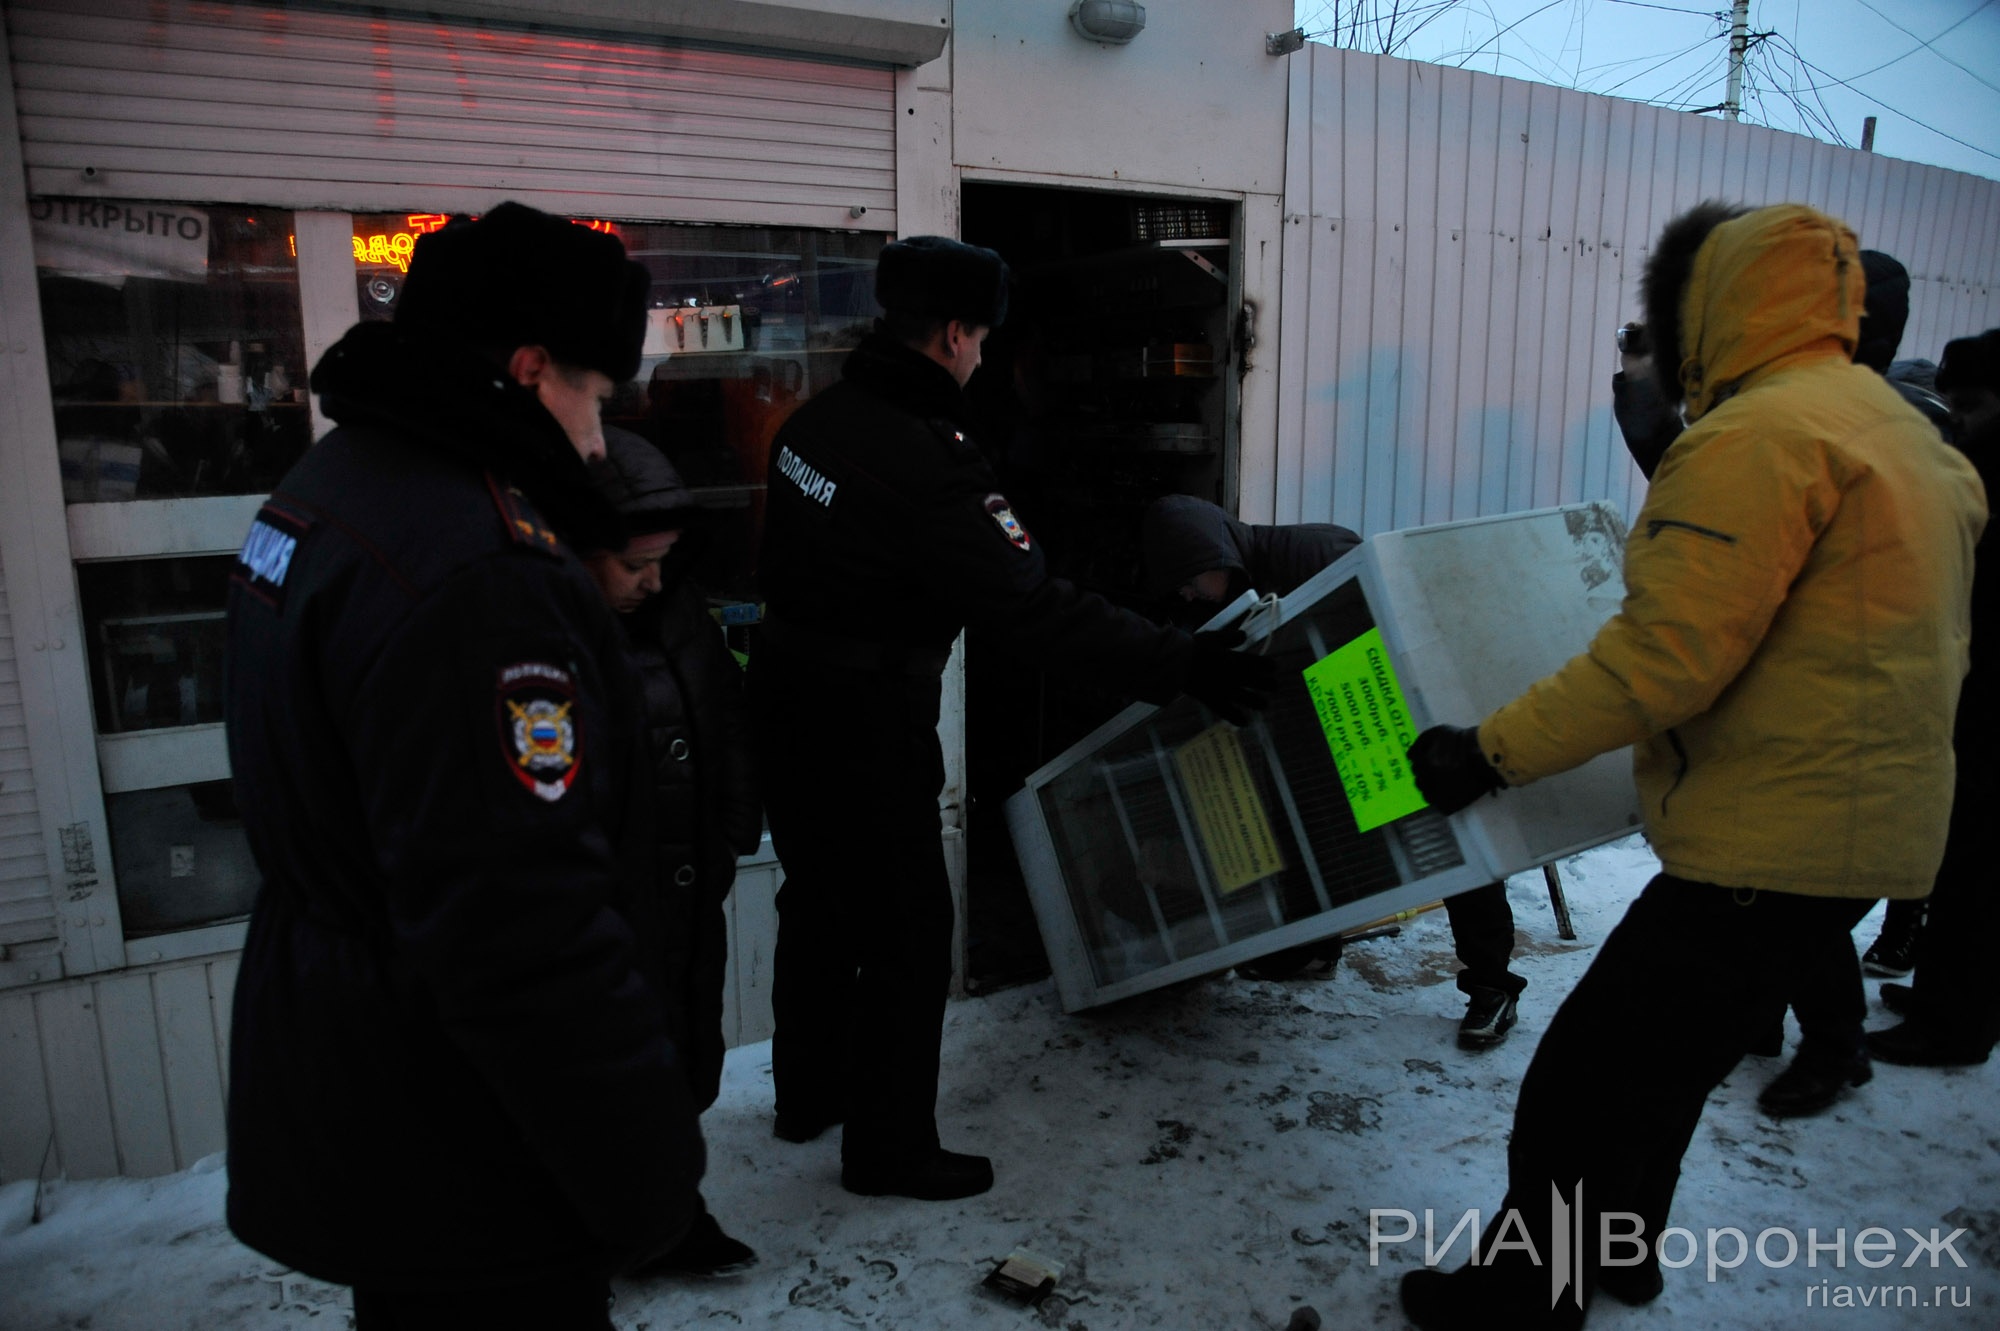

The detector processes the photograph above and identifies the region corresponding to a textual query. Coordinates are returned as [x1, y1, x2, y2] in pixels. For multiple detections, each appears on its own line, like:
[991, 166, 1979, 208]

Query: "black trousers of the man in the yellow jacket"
[1472, 873, 1874, 1327]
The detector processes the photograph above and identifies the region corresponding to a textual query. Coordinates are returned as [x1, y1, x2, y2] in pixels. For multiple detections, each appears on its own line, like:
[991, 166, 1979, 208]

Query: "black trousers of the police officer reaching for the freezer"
[750, 646, 954, 1163]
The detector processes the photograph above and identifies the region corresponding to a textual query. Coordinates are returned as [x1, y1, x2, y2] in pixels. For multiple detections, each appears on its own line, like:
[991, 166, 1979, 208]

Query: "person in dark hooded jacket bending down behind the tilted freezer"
[1140, 494, 1528, 1049]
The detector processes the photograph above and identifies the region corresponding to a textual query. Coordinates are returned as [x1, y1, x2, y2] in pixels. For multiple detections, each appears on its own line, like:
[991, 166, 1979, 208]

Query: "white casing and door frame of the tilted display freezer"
[1008, 504, 1640, 1011]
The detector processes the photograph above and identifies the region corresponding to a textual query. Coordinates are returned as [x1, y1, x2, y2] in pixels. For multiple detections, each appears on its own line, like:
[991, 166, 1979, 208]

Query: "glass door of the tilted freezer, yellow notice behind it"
[1036, 578, 1466, 989]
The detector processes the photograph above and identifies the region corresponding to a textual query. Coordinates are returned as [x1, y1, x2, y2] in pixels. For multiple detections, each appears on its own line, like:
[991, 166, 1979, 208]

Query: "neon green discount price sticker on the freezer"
[1302, 628, 1428, 831]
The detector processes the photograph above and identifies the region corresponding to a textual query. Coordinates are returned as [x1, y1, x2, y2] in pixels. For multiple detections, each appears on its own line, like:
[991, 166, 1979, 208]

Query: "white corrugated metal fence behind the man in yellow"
[1272, 46, 2000, 532]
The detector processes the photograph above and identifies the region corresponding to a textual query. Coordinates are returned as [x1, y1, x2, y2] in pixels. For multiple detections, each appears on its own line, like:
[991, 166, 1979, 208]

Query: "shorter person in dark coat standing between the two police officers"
[584, 426, 764, 1275]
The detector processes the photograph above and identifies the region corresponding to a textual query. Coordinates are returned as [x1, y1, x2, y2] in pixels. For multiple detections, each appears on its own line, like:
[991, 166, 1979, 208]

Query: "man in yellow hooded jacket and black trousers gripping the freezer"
[1402, 204, 1986, 1331]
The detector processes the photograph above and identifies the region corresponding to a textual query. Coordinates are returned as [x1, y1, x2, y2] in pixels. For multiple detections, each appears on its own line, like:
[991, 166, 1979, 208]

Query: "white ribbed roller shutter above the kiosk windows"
[6, 0, 896, 230]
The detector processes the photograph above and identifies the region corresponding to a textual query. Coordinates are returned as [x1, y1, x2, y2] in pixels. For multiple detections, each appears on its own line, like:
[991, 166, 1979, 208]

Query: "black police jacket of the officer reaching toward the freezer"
[752, 334, 1192, 701]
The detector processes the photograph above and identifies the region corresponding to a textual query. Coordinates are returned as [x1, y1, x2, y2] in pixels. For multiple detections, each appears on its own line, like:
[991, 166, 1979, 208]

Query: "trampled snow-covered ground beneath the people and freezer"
[0, 839, 2000, 1331]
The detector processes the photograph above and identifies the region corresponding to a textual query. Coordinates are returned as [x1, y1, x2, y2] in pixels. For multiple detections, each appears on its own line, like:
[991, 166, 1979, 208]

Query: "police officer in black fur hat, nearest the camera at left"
[226, 204, 702, 1331]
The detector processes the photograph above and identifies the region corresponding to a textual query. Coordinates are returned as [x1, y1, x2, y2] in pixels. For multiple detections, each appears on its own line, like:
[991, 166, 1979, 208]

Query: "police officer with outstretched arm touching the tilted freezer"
[750, 236, 1270, 1199]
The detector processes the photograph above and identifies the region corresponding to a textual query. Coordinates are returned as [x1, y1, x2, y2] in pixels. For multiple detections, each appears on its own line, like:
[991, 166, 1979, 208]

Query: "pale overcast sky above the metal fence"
[1296, 0, 2000, 180]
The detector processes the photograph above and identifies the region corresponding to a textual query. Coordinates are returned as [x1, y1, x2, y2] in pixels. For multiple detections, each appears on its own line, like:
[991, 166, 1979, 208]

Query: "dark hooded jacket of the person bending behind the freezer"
[1140, 494, 1362, 598]
